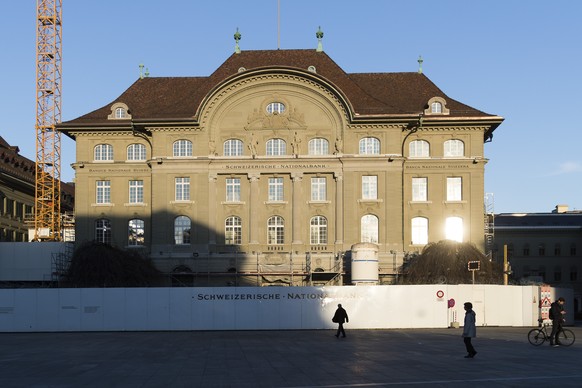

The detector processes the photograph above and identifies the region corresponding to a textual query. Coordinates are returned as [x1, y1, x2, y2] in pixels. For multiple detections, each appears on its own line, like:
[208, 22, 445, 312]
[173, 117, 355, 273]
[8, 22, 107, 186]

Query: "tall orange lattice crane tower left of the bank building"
[34, 0, 62, 241]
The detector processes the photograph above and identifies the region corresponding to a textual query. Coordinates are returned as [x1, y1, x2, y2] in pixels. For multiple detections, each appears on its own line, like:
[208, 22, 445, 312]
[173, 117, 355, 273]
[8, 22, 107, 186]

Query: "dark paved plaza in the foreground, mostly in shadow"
[0, 324, 582, 388]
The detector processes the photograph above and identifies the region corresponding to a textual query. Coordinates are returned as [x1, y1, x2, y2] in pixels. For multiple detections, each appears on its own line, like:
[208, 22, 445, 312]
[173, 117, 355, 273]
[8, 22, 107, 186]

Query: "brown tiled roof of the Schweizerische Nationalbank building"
[59, 50, 496, 129]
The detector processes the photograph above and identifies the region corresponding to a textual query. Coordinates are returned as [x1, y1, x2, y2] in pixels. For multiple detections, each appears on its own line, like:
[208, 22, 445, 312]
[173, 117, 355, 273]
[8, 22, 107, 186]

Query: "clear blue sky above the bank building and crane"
[0, 0, 582, 213]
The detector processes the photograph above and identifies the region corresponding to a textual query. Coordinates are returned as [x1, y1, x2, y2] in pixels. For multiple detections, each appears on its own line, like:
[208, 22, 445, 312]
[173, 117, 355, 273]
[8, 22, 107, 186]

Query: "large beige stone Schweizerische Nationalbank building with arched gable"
[58, 50, 503, 285]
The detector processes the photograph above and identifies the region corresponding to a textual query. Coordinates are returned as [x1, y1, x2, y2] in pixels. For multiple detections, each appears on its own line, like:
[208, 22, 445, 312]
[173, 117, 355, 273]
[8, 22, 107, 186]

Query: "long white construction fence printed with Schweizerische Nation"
[0, 285, 573, 332]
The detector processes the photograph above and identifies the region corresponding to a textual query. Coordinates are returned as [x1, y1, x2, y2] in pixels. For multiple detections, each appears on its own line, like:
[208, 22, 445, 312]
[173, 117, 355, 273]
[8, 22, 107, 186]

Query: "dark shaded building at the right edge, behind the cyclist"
[494, 205, 582, 315]
